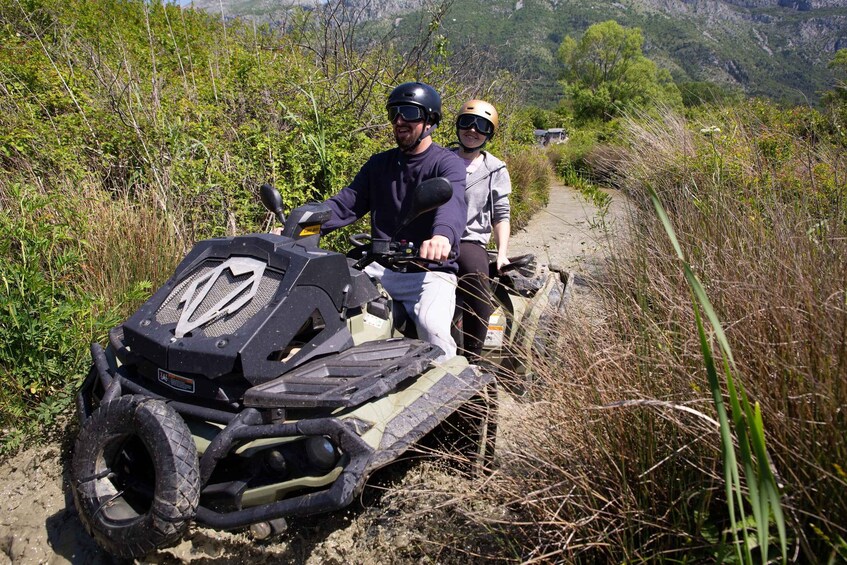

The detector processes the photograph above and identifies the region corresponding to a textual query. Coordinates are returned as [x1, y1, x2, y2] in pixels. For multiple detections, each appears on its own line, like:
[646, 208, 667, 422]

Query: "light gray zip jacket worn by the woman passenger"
[462, 151, 512, 246]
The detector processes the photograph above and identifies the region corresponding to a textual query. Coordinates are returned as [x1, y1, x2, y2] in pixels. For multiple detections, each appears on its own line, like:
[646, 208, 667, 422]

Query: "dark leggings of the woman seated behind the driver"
[456, 241, 494, 356]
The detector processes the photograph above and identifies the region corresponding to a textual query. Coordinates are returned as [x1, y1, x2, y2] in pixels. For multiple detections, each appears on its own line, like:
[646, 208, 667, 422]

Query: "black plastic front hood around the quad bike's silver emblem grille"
[123, 234, 377, 384]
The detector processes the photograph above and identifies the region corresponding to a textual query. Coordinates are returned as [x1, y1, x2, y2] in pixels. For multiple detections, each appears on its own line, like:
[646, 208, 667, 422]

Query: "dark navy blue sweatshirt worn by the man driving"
[321, 143, 467, 272]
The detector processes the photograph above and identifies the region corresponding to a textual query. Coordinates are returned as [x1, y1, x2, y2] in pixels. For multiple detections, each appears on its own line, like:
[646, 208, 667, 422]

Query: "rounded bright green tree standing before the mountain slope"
[559, 20, 682, 120]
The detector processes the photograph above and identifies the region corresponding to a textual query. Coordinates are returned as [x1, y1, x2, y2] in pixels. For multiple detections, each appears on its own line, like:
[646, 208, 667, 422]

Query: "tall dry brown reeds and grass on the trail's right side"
[428, 107, 847, 561]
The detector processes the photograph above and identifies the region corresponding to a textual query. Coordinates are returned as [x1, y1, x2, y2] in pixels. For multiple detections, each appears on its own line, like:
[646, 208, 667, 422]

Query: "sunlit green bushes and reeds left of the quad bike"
[0, 0, 549, 451]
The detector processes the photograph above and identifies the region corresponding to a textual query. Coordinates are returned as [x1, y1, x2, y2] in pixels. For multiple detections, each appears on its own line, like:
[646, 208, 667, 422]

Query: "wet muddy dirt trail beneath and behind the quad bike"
[0, 185, 622, 565]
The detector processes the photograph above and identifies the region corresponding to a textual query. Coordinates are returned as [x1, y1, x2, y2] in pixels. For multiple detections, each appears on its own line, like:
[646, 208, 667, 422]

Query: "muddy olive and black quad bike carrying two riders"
[71, 179, 495, 558]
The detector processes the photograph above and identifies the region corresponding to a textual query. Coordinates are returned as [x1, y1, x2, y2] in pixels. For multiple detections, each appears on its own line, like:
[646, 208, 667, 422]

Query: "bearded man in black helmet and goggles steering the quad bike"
[321, 82, 467, 360]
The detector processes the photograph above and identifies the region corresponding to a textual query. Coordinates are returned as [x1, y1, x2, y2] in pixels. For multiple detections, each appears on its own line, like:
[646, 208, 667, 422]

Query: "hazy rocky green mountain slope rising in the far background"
[186, 0, 847, 105]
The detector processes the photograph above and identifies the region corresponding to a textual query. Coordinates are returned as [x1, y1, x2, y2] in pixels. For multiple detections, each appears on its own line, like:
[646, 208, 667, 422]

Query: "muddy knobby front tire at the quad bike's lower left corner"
[71, 396, 200, 558]
